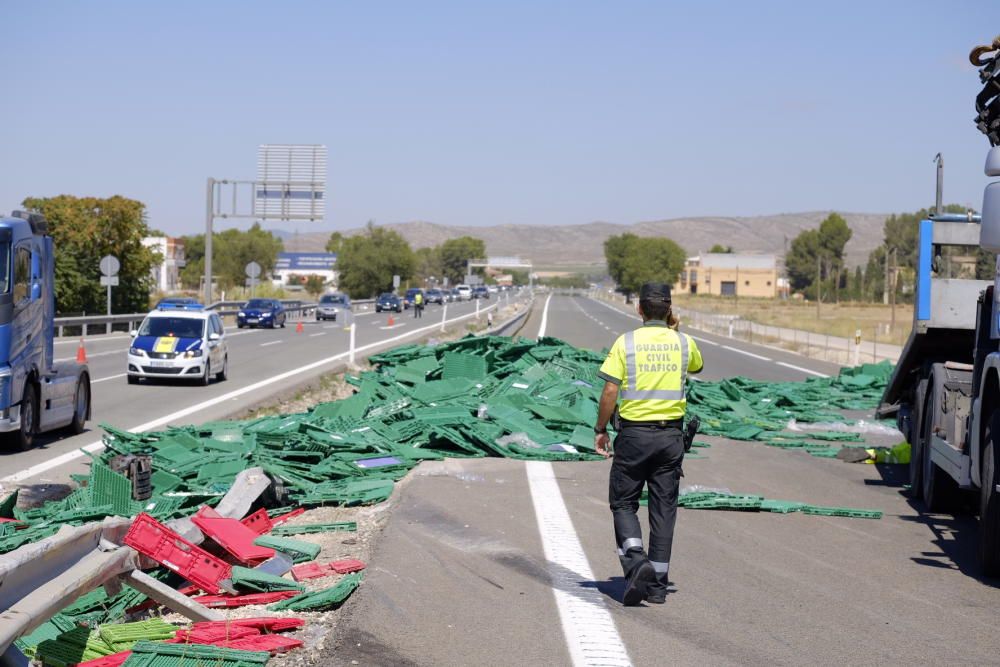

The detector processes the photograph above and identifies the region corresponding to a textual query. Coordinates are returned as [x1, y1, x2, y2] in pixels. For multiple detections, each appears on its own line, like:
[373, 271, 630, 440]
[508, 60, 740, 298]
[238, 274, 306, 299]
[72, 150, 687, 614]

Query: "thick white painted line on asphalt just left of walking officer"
[525, 464, 632, 666]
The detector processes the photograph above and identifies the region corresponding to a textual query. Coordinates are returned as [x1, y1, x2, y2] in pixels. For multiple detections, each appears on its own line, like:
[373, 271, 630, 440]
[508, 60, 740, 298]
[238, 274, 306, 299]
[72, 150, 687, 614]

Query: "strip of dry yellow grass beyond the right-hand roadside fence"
[674, 294, 913, 345]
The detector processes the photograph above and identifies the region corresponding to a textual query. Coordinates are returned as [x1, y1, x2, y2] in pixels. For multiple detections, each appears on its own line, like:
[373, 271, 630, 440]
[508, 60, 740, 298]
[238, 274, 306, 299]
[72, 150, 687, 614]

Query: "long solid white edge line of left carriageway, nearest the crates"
[0, 306, 508, 483]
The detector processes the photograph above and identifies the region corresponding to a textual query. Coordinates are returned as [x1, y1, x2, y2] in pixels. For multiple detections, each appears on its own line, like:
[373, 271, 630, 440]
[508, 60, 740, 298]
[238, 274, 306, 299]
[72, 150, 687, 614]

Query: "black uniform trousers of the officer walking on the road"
[608, 422, 684, 593]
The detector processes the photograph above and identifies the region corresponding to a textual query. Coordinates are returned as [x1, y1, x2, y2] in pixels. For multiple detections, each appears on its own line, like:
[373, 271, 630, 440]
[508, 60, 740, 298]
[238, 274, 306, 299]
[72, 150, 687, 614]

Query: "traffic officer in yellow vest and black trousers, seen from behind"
[594, 283, 703, 606]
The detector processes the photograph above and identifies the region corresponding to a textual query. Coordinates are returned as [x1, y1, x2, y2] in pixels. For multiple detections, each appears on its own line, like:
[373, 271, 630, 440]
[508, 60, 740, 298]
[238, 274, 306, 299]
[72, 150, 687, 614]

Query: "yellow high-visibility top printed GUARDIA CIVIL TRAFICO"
[597, 320, 704, 421]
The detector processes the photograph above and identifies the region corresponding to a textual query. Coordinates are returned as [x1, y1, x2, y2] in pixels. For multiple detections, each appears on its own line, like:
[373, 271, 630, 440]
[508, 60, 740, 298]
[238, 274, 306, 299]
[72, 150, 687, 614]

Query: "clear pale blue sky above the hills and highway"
[0, 0, 1000, 234]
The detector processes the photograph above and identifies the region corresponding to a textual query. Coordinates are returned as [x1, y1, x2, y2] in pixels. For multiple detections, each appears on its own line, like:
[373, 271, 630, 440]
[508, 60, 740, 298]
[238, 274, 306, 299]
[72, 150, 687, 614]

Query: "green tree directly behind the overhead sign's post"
[181, 222, 283, 290]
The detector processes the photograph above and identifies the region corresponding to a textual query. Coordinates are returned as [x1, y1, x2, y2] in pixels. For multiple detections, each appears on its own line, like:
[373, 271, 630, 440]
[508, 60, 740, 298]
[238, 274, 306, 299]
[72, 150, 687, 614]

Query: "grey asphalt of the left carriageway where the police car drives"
[0, 295, 516, 489]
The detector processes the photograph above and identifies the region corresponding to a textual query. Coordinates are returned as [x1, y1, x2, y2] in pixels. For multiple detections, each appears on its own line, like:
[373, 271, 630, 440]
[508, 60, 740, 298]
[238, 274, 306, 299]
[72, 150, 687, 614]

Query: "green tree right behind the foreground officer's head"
[604, 232, 687, 294]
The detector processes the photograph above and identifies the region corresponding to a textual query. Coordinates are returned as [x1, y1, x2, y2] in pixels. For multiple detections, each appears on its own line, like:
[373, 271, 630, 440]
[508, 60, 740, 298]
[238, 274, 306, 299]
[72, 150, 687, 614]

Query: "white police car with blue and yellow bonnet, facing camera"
[127, 305, 229, 385]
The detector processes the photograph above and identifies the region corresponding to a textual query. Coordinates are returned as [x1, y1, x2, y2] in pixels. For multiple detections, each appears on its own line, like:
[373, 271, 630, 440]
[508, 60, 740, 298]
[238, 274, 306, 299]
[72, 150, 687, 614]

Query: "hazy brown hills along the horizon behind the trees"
[271, 211, 886, 269]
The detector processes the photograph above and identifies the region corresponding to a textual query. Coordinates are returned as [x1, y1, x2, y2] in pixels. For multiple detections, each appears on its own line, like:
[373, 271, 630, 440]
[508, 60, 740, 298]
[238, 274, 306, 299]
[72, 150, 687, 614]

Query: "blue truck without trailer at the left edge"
[0, 211, 90, 451]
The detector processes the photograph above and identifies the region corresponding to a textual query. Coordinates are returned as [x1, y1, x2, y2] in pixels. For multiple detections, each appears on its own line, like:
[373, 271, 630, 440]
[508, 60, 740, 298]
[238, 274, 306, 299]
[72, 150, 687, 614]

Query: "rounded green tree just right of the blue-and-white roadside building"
[337, 221, 416, 299]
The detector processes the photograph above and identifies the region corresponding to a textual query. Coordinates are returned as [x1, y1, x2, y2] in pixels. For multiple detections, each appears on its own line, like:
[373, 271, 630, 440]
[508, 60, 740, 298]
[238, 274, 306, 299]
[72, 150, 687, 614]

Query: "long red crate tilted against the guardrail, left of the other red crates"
[125, 512, 233, 593]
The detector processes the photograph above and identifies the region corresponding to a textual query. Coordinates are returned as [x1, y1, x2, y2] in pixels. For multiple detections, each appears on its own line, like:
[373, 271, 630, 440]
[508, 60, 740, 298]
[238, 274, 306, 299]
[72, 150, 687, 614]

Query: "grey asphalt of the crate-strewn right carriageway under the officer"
[334, 296, 1000, 665]
